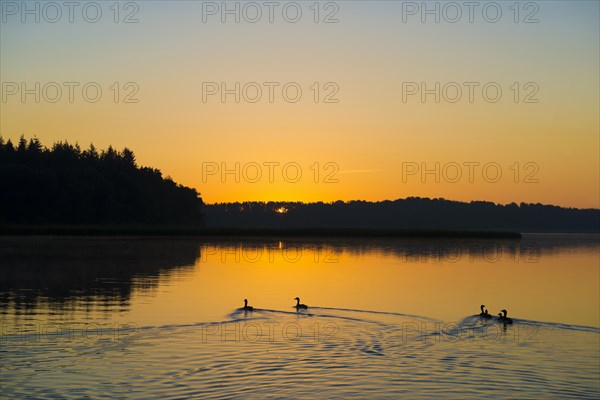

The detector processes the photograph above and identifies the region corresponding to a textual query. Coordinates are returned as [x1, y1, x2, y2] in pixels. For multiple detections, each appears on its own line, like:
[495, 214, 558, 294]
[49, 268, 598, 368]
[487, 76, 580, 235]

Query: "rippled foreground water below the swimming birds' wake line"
[0, 308, 600, 399]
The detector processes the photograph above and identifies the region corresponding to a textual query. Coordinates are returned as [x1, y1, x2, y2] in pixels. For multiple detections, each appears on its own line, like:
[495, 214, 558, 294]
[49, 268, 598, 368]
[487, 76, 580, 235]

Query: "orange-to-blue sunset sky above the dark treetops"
[0, 1, 600, 208]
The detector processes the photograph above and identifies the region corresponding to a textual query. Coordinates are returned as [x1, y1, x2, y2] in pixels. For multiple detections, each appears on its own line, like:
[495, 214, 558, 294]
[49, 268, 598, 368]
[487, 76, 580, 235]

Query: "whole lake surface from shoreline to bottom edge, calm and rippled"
[0, 235, 600, 399]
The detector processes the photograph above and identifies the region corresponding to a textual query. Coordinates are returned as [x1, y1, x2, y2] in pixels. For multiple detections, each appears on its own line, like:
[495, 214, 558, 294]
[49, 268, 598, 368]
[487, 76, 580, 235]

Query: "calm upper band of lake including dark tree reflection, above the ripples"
[0, 235, 600, 327]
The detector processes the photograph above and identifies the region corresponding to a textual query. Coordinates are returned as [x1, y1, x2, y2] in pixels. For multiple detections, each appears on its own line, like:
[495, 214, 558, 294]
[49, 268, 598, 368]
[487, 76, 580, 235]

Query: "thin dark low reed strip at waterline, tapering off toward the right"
[0, 225, 522, 239]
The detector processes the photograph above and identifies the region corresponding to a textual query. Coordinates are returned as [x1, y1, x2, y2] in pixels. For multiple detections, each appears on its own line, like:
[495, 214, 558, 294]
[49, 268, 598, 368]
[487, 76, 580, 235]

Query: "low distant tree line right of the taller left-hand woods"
[205, 197, 600, 232]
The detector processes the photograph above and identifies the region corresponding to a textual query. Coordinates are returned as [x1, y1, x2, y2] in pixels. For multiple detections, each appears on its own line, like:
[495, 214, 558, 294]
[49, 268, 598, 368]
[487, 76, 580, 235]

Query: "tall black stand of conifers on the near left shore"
[0, 136, 203, 226]
